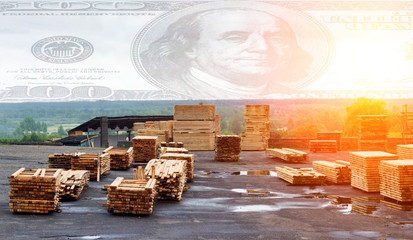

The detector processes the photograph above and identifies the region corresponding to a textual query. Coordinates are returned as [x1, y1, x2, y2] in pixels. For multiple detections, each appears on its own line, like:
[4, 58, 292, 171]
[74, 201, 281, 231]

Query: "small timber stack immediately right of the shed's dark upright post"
[103, 147, 133, 170]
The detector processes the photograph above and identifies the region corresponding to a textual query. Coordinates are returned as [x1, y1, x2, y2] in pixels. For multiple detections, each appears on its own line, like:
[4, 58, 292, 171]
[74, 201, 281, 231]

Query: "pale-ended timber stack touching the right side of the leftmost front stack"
[59, 170, 90, 200]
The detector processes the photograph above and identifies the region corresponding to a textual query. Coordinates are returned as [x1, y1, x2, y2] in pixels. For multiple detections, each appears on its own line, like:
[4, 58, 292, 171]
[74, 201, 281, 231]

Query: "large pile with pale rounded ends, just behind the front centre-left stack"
[145, 159, 186, 201]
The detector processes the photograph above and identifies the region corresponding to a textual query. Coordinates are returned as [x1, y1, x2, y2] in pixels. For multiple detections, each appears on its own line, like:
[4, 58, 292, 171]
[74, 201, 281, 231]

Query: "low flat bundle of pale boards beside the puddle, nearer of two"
[275, 167, 327, 185]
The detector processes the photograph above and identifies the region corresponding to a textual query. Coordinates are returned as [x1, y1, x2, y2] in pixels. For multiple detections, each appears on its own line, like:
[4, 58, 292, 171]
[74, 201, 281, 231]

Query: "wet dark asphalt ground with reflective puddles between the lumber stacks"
[0, 146, 413, 239]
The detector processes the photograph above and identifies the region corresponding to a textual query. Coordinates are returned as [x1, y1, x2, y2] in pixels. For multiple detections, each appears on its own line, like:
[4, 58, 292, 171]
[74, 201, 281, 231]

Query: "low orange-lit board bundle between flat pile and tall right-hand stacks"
[313, 161, 351, 184]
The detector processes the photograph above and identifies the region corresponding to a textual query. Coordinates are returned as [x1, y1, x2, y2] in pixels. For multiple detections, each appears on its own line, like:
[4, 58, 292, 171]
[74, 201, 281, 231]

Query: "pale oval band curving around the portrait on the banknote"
[131, 1, 335, 95]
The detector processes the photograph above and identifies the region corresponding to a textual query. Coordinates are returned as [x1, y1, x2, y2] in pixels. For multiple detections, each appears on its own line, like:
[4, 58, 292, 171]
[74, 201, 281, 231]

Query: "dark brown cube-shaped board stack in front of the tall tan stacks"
[215, 135, 241, 162]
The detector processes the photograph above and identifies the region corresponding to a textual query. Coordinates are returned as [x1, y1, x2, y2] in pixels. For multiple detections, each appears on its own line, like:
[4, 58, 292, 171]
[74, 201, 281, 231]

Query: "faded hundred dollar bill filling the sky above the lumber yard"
[0, 0, 413, 102]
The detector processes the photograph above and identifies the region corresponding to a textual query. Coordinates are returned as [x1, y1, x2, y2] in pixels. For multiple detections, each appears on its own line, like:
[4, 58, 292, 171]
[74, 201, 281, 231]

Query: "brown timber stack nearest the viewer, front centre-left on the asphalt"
[105, 177, 156, 215]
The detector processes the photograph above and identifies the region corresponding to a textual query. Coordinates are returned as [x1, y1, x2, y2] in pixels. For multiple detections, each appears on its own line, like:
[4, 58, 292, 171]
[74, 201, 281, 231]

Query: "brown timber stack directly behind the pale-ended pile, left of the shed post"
[72, 153, 110, 179]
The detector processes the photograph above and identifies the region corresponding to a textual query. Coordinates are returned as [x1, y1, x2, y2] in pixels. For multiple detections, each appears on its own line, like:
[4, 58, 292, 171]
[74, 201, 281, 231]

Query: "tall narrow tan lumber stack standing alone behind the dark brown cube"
[241, 105, 270, 151]
